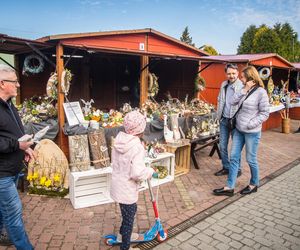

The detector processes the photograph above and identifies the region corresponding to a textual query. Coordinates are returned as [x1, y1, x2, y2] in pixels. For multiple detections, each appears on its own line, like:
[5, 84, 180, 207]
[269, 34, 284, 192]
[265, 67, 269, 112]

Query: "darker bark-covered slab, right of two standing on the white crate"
[89, 128, 110, 169]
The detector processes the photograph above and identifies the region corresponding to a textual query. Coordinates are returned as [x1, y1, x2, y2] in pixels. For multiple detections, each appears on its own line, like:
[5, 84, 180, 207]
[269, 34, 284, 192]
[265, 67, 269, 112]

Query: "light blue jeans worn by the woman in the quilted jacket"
[227, 129, 261, 189]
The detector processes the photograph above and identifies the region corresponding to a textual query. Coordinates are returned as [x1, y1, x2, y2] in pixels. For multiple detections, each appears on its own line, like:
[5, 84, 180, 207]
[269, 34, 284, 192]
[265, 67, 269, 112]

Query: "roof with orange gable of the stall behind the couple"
[201, 53, 294, 68]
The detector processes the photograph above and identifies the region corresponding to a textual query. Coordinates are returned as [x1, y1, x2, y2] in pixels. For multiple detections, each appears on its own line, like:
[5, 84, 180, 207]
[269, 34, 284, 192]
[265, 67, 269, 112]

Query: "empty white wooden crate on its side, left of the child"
[69, 167, 113, 209]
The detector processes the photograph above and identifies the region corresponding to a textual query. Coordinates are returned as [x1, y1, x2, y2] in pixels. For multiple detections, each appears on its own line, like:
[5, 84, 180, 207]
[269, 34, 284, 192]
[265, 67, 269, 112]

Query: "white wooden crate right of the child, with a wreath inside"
[139, 152, 175, 191]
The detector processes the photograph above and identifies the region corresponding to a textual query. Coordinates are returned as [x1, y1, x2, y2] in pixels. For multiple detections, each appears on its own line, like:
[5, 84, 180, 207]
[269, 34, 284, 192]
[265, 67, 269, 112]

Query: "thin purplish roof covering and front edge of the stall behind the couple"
[201, 53, 294, 68]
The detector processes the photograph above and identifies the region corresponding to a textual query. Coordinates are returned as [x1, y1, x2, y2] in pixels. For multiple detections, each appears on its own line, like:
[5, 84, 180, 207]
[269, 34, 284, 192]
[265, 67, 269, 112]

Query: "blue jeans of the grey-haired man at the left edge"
[0, 175, 33, 250]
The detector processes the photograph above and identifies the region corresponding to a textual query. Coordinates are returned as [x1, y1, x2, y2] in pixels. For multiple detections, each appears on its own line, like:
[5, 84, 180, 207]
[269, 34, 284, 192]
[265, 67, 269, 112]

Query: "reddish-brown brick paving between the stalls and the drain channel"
[0, 121, 300, 250]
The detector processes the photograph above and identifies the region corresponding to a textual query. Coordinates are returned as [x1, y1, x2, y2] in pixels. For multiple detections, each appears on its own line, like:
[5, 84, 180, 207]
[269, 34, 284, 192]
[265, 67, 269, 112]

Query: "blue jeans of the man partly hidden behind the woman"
[219, 118, 241, 170]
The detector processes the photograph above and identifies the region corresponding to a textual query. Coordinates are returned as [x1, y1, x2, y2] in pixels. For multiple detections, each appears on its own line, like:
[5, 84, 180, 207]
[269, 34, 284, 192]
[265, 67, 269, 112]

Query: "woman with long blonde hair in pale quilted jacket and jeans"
[213, 66, 269, 196]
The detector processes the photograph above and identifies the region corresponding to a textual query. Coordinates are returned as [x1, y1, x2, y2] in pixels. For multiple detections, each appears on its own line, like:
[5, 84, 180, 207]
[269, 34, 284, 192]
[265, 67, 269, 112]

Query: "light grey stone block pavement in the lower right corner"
[154, 164, 300, 250]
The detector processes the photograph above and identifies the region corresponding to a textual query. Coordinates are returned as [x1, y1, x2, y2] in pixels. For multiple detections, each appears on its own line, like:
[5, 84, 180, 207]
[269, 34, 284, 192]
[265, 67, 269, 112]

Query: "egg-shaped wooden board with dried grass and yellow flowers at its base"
[27, 139, 69, 197]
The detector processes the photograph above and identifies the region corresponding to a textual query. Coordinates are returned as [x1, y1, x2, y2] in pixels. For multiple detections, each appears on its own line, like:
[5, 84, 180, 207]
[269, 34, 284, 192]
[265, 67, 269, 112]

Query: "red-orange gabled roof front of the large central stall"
[38, 29, 207, 60]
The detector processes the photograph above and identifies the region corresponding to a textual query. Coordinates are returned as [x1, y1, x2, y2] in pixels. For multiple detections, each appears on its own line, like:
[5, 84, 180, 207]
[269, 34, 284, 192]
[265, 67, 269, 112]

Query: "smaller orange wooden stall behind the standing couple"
[201, 53, 293, 130]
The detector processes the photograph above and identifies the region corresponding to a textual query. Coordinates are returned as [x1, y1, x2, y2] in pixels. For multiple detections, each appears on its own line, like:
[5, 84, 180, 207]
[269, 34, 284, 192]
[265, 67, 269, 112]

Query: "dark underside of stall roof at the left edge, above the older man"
[0, 34, 53, 55]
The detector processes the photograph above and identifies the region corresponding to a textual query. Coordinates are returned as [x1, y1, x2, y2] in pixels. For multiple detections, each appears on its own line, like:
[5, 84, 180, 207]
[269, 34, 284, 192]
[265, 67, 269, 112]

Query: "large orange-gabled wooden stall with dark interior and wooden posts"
[4, 29, 206, 155]
